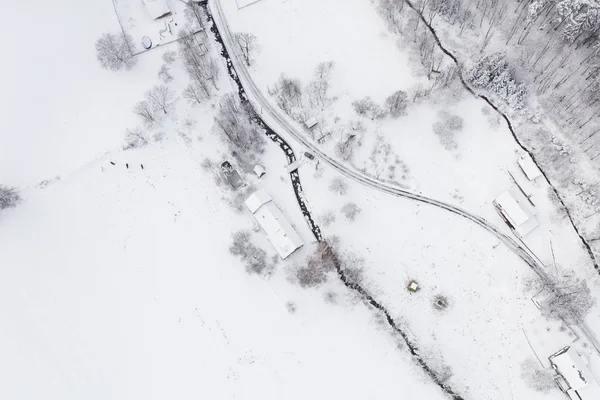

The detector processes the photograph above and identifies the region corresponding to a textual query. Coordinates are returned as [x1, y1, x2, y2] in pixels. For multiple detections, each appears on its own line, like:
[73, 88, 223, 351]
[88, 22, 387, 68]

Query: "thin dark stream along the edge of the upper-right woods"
[404, 0, 600, 274]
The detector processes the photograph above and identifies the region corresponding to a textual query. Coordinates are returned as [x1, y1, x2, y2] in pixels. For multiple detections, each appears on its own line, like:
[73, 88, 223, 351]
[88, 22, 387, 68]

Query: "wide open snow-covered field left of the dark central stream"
[0, 0, 454, 399]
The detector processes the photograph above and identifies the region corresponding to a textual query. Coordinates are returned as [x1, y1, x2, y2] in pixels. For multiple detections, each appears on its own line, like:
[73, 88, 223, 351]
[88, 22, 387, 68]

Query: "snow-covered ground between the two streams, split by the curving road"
[221, 0, 600, 399]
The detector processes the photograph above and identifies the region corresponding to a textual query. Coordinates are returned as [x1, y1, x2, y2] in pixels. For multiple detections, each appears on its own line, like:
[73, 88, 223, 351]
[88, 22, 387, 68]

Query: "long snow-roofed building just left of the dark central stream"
[245, 189, 303, 259]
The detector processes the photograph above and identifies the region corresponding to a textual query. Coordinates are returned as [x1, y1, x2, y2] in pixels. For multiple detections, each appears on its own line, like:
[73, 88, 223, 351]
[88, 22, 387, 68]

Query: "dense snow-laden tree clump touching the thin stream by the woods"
[466, 53, 527, 110]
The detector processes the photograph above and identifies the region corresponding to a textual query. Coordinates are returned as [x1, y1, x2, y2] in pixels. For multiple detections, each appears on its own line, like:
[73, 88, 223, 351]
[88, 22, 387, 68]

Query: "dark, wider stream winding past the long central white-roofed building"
[204, 2, 464, 400]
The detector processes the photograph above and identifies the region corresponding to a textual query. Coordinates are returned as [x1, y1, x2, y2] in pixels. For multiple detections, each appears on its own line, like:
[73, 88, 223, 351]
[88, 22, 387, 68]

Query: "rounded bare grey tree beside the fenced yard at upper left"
[96, 33, 136, 71]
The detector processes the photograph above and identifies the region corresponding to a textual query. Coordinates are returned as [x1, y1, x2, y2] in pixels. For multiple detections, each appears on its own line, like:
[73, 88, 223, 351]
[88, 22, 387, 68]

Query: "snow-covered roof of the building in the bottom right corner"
[550, 347, 600, 400]
